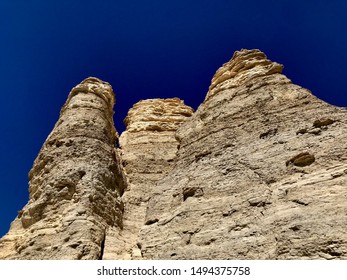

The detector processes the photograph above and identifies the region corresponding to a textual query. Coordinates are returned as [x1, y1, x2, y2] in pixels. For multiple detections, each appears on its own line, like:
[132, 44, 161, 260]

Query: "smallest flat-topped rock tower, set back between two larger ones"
[104, 98, 193, 259]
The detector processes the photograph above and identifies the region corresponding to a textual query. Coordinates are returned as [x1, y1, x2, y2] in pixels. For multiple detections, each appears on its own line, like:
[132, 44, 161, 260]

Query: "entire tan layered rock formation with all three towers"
[0, 50, 347, 259]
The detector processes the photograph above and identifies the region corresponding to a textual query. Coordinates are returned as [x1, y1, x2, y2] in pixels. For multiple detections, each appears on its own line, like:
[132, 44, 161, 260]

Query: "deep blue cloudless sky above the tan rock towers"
[0, 0, 347, 236]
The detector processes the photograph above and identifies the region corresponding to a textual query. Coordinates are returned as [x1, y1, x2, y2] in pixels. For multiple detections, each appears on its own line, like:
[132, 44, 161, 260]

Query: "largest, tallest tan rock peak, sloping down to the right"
[138, 50, 347, 259]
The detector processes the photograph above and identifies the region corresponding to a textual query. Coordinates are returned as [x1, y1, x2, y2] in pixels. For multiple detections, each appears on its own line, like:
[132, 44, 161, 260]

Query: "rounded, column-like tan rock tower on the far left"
[0, 78, 125, 259]
